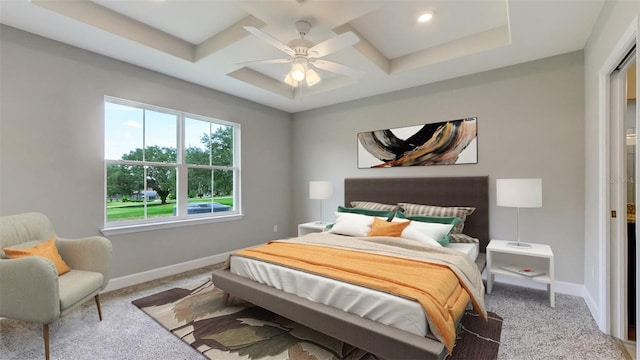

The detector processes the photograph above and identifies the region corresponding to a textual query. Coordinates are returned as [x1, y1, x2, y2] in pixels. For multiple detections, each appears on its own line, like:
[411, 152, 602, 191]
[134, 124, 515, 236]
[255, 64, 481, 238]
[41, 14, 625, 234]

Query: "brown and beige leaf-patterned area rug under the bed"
[132, 279, 502, 360]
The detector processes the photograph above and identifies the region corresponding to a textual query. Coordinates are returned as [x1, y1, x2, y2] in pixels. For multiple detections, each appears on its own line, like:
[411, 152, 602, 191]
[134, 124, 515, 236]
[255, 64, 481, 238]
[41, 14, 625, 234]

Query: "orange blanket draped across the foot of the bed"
[234, 242, 470, 353]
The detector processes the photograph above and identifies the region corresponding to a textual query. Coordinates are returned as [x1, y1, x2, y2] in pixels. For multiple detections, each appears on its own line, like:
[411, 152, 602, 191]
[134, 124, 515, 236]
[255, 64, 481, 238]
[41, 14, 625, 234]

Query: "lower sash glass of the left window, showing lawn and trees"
[106, 165, 176, 222]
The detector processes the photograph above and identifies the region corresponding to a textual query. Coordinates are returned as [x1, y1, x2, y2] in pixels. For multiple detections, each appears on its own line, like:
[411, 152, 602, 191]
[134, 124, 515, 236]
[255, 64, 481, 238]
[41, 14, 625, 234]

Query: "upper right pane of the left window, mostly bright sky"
[144, 110, 178, 163]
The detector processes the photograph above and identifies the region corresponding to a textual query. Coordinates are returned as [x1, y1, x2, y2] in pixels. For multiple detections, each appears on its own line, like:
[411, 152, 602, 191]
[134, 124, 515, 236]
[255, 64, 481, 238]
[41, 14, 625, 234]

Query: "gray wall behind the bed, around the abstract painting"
[293, 52, 585, 284]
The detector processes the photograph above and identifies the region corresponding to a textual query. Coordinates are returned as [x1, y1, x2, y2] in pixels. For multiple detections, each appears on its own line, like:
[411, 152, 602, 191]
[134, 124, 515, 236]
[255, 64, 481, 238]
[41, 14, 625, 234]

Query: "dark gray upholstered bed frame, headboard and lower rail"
[212, 176, 489, 359]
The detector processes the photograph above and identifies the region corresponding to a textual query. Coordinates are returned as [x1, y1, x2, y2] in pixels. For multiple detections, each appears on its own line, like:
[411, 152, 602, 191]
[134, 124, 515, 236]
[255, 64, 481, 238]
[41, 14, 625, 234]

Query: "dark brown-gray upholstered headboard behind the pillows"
[344, 176, 489, 252]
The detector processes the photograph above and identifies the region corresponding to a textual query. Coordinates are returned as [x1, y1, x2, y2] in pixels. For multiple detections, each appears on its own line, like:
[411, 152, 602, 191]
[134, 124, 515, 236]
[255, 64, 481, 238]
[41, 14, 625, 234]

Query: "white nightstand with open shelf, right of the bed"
[487, 240, 556, 307]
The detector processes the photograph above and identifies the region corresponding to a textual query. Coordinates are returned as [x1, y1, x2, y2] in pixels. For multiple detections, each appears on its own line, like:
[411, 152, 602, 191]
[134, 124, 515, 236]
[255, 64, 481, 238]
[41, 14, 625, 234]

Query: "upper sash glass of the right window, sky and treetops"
[185, 118, 233, 166]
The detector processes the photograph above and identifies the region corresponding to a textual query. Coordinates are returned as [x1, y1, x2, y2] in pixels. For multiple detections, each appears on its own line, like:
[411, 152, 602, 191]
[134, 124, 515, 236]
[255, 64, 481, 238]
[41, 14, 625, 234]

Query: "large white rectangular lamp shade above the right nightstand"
[496, 179, 542, 208]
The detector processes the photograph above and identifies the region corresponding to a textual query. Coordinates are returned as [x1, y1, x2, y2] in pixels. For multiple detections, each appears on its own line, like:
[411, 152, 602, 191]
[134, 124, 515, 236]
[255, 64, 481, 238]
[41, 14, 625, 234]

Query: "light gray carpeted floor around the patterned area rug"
[0, 267, 625, 360]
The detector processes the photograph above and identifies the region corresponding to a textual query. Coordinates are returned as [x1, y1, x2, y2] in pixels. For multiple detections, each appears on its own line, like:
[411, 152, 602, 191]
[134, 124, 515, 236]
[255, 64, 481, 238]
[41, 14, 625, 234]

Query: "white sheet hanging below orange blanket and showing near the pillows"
[230, 243, 479, 336]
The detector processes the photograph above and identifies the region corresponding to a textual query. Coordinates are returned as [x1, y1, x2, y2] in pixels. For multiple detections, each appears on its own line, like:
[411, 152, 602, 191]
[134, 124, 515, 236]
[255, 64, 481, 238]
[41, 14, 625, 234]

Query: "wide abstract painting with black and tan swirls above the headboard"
[358, 117, 478, 169]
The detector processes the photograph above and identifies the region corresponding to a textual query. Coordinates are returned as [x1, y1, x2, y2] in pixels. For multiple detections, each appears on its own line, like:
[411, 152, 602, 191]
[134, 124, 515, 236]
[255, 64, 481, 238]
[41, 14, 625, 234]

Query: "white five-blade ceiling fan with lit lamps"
[244, 20, 361, 87]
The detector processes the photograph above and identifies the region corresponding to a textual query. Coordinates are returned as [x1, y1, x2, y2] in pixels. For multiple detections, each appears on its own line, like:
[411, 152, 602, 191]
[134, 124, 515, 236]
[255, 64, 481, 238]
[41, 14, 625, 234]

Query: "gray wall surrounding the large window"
[0, 26, 291, 277]
